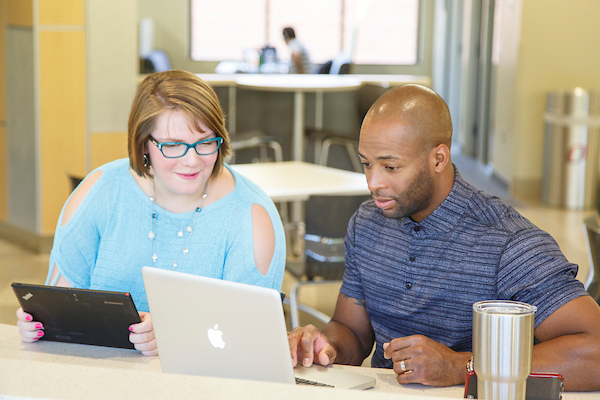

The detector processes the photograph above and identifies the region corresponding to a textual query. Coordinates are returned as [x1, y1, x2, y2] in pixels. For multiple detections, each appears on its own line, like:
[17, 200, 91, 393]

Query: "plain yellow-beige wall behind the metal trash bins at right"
[508, 0, 600, 195]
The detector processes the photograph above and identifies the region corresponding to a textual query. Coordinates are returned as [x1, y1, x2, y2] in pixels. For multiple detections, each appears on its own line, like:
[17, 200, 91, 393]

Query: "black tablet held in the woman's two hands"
[12, 283, 141, 349]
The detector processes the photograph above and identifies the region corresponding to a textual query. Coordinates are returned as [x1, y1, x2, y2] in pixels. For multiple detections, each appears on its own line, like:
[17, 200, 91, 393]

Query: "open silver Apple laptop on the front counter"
[142, 267, 375, 389]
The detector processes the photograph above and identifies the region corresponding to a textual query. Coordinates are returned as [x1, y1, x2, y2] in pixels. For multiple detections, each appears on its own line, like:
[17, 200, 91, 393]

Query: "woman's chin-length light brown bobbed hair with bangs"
[127, 70, 231, 177]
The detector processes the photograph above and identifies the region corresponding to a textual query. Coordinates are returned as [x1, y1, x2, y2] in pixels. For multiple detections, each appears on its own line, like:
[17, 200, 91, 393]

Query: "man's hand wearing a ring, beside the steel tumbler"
[383, 335, 471, 386]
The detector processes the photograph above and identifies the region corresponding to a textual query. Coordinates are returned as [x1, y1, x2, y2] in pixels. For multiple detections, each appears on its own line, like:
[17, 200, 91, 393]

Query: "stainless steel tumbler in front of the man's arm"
[473, 300, 537, 400]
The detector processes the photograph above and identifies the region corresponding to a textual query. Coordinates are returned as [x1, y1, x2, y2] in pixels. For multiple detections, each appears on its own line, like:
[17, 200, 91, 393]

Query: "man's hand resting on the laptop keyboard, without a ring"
[288, 325, 337, 367]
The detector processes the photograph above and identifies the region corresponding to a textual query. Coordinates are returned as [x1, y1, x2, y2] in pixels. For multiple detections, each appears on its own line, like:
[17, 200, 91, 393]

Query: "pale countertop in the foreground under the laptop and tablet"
[0, 324, 600, 400]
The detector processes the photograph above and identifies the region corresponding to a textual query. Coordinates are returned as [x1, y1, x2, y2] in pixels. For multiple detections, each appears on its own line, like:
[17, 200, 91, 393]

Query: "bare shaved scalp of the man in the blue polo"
[365, 85, 452, 152]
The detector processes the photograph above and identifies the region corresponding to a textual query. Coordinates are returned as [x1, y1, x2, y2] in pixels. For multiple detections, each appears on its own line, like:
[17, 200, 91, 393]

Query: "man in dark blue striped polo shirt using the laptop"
[289, 85, 600, 390]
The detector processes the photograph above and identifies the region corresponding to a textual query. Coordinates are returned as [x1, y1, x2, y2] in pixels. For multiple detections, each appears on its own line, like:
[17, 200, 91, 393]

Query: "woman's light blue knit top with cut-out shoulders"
[46, 159, 286, 311]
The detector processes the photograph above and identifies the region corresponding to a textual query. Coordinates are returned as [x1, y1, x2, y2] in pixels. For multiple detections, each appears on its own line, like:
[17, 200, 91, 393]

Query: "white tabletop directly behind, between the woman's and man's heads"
[231, 161, 370, 202]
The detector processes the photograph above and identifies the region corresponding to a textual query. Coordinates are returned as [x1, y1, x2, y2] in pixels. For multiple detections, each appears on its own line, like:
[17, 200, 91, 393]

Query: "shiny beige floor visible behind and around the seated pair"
[0, 158, 593, 334]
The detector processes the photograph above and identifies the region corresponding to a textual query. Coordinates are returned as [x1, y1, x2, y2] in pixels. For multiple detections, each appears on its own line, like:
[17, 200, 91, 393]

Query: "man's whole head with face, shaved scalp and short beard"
[358, 85, 454, 222]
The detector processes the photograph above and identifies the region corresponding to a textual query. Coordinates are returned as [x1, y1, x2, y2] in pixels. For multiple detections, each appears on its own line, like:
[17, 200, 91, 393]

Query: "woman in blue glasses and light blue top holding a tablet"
[17, 70, 286, 355]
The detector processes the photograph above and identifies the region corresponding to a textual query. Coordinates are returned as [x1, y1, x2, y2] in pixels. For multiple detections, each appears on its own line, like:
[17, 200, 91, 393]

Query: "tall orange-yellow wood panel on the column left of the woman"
[39, 31, 86, 234]
